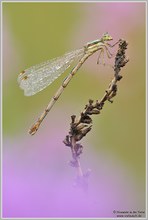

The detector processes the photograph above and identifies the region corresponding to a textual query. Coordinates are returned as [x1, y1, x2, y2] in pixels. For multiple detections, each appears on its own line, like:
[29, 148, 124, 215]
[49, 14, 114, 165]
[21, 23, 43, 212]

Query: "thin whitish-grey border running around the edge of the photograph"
[0, 0, 148, 220]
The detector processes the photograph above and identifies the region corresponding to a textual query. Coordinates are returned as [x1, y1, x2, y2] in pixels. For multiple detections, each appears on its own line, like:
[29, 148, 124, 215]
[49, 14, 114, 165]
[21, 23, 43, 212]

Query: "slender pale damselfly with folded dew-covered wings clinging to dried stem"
[18, 33, 118, 135]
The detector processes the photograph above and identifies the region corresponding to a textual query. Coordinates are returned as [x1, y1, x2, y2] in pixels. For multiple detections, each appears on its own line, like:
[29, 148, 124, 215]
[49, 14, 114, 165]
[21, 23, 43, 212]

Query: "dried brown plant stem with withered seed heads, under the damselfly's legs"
[63, 39, 129, 189]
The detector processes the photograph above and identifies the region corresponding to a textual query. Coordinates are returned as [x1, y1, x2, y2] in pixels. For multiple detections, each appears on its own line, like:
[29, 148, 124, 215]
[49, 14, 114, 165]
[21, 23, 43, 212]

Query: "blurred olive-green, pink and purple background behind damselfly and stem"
[2, 2, 146, 218]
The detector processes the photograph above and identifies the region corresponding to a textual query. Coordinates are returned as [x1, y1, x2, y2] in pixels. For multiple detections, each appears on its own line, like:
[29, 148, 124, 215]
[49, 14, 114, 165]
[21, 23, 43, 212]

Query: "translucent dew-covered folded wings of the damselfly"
[18, 48, 84, 96]
